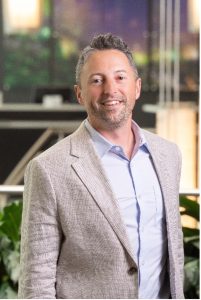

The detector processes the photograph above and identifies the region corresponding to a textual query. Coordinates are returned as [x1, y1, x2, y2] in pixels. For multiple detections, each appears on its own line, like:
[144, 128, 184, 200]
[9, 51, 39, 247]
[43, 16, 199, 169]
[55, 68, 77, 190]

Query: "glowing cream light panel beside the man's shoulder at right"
[156, 102, 197, 189]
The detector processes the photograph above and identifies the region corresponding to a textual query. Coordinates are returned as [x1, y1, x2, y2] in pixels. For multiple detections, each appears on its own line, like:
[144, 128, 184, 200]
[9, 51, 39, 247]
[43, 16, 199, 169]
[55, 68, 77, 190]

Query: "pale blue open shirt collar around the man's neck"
[84, 119, 149, 158]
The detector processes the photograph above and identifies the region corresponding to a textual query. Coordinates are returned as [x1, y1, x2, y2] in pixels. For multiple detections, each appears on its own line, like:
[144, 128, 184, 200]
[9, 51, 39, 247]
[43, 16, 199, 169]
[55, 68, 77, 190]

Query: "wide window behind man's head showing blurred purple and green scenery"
[0, 0, 199, 102]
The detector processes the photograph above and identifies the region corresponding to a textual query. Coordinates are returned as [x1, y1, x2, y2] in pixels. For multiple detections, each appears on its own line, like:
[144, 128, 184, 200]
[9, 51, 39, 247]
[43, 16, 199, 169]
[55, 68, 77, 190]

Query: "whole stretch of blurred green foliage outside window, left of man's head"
[4, 29, 78, 89]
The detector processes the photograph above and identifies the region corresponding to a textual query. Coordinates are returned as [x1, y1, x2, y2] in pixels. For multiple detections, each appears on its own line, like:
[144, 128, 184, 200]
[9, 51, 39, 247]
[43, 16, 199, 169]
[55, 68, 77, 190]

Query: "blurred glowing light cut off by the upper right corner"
[187, 0, 201, 33]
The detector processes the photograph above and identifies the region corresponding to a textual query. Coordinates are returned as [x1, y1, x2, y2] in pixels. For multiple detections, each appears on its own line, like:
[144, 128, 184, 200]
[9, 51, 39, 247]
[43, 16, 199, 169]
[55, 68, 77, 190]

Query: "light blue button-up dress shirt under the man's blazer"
[85, 120, 170, 299]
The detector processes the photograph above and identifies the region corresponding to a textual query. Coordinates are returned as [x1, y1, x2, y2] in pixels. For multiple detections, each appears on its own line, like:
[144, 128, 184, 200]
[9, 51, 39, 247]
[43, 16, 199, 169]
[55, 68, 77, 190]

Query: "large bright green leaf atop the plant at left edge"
[0, 202, 22, 244]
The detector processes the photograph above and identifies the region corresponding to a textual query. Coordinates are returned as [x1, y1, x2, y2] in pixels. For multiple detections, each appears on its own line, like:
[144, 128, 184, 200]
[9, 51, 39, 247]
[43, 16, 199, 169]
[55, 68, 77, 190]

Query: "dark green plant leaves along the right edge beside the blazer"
[180, 196, 200, 299]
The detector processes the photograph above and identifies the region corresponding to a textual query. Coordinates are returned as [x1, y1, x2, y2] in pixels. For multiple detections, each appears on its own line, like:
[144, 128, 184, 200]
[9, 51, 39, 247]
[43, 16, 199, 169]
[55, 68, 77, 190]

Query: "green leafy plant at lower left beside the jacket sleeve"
[0, 201, 22, 299]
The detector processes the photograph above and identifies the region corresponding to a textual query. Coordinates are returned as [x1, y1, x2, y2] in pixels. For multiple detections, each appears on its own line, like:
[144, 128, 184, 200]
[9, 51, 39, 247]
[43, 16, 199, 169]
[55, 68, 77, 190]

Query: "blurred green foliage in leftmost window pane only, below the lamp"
[4, 34, 50, 89]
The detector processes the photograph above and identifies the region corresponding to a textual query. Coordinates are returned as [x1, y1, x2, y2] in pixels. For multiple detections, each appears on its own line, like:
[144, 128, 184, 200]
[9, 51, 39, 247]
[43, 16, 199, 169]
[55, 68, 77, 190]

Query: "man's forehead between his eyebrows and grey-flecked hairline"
[83, 49, 132, 71]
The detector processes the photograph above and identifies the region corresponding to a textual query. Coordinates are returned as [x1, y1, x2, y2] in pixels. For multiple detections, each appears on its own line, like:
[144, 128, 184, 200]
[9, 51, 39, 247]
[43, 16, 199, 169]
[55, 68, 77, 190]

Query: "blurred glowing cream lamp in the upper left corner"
[3, 0, 41, 33]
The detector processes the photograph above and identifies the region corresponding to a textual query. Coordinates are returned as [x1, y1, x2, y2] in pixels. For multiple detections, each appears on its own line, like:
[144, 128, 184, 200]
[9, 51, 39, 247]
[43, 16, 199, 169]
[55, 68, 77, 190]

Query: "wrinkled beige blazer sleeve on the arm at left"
[18, 159, 61, 299]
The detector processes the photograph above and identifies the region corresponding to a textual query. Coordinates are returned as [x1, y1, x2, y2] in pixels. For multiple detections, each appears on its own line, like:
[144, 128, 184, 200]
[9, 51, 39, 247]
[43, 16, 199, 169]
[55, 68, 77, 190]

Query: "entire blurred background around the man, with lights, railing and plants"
[0, 0, 200, 298]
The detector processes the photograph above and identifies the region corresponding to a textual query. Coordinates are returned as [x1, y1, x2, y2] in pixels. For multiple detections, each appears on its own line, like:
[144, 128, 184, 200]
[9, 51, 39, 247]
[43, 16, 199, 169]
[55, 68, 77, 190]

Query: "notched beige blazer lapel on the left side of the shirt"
[71, 123, 137, 260]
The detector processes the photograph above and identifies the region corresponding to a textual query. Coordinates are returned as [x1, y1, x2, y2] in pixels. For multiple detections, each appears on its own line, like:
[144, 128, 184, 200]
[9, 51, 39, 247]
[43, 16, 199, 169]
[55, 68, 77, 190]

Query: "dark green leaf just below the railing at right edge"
[180, 196, 200, 221]
